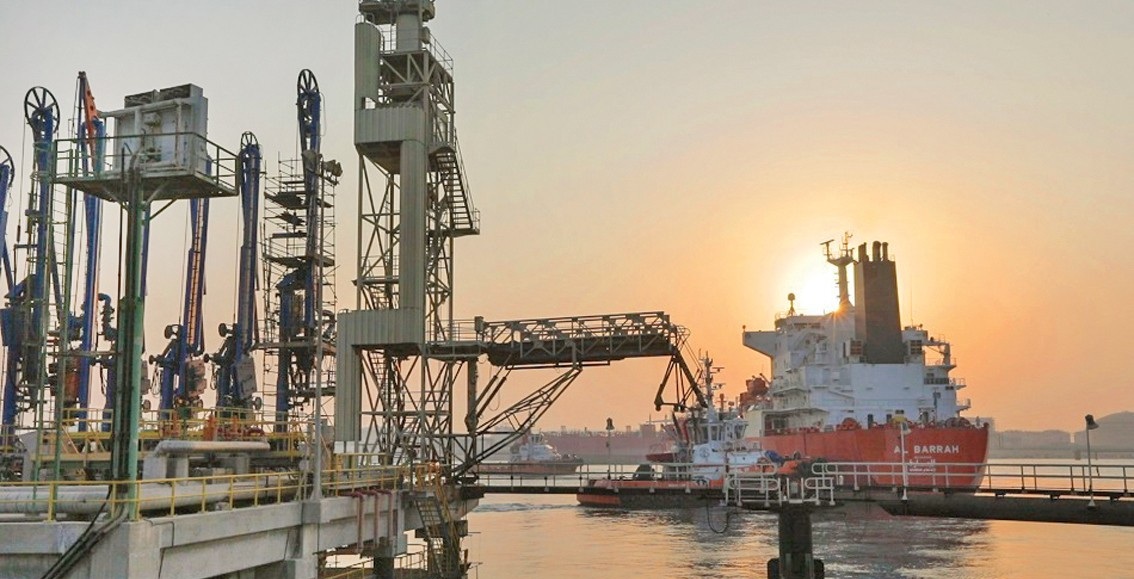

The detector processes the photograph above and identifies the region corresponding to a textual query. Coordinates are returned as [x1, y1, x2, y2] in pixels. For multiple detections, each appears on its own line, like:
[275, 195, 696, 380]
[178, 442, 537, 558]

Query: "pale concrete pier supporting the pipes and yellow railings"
[0, 491, 476, 579]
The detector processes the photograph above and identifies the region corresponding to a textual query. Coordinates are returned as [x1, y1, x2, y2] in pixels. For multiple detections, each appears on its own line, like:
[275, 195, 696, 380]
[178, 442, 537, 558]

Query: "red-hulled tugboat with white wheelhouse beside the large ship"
[575, 357, 780, 508]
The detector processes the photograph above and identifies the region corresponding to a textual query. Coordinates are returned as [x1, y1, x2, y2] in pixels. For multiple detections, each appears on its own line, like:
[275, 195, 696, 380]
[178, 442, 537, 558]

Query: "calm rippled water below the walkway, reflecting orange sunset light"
[465, 495, 1134, 579]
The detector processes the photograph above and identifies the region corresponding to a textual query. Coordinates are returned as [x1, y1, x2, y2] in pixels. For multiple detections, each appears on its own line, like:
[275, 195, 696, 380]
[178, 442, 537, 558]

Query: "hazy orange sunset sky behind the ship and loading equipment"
[0, 0, 1134, 431]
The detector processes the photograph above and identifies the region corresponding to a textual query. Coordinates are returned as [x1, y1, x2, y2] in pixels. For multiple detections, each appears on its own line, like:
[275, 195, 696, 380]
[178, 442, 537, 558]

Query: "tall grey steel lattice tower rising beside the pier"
[336, 0, 480, 466]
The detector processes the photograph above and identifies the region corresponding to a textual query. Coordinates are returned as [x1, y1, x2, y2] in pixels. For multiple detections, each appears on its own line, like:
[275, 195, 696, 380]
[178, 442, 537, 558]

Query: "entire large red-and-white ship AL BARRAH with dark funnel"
[744, 236, 989, 487]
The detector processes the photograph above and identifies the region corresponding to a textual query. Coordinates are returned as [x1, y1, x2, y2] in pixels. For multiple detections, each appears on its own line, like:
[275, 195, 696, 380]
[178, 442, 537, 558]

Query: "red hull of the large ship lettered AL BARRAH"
[759, 426, 989, 488]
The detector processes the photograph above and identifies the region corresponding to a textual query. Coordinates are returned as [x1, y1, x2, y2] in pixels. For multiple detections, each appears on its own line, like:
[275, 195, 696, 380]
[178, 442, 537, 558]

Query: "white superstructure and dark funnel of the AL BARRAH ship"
[744, 241, 970, 433]
